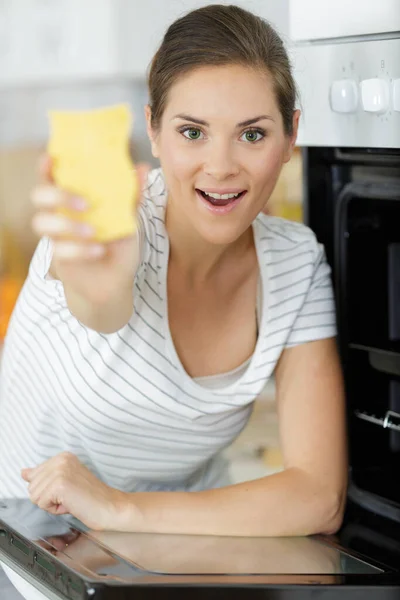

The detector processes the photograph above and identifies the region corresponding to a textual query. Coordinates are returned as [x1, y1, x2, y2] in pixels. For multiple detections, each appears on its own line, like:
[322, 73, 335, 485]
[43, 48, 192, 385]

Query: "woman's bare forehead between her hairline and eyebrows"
[165, 65, 279, 121]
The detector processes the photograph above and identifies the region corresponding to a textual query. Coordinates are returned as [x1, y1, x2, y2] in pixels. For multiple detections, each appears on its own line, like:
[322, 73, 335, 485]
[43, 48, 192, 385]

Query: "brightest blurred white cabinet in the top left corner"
[0, 0, 118, 87]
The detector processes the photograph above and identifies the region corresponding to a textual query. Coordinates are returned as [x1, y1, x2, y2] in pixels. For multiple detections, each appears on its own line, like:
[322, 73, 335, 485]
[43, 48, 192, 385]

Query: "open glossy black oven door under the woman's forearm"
[0, 500, 400, 600]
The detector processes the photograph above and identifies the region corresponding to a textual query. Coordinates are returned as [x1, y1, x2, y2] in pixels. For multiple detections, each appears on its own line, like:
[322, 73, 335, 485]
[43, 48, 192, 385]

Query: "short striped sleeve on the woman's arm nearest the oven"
[286, 236, 337, 347]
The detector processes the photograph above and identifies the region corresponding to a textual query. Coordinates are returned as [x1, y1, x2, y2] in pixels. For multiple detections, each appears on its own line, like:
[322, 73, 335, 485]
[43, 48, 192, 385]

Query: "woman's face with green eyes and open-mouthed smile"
[146, 65, 299, 244]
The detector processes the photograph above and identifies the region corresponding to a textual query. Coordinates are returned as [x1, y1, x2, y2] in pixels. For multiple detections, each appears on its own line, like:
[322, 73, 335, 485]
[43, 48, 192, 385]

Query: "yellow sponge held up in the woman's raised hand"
[48, 104, 139, 242]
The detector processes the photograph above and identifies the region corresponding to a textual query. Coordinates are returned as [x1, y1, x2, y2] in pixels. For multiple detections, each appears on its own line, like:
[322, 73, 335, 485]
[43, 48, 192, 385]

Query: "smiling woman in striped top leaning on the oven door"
[0, 5, 346, 536]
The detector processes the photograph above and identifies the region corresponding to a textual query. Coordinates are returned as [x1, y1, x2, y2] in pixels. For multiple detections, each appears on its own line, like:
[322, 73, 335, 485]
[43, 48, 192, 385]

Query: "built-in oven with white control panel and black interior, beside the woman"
[291, 0, 400, 593]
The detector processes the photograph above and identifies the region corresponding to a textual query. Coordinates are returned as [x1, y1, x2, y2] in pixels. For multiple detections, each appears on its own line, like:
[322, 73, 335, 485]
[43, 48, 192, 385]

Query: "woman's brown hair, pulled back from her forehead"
[148, 4, 296, 135]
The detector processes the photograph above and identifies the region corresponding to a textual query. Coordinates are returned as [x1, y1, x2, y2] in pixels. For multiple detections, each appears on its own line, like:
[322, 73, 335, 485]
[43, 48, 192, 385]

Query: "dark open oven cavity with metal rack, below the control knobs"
[304, 148, 400, 522]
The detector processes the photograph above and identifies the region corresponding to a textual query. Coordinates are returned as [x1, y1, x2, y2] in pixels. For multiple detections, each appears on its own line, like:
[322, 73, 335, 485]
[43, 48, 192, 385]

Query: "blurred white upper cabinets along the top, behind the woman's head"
[0, 0, 289, 88]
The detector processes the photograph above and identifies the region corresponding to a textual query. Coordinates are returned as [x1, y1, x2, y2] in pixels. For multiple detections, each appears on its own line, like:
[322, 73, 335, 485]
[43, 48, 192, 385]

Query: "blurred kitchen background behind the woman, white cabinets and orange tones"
[0, 0, 302, 481]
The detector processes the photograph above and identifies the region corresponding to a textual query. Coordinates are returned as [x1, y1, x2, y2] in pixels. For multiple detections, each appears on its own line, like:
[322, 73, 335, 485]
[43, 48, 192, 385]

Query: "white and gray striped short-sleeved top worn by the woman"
[0, 169, 336, 497]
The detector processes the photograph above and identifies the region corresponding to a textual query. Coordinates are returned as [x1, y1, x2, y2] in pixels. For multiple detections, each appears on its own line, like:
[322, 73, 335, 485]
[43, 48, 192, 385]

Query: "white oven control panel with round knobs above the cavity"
[291, 38, 400, 148]
